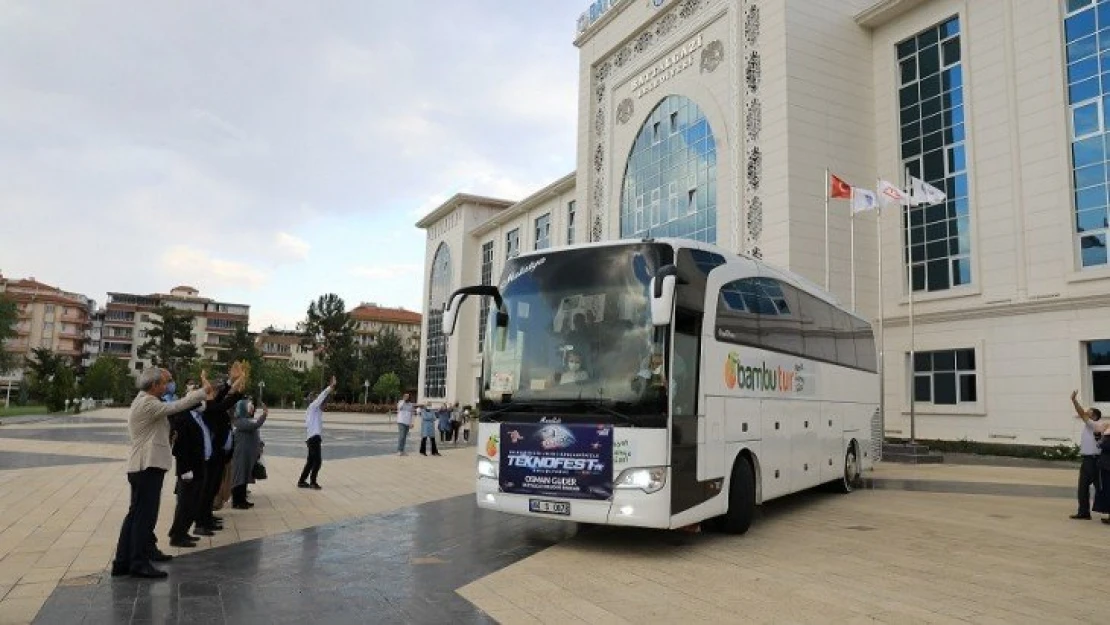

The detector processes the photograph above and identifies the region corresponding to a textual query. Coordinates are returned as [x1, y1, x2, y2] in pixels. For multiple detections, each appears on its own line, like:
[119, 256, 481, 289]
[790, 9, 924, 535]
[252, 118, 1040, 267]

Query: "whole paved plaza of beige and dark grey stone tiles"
[0, 410, 1110, 624]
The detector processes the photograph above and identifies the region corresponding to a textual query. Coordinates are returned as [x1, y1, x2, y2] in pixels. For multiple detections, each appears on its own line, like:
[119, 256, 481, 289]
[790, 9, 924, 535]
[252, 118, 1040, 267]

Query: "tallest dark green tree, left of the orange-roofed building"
[301, 293, 362, 397]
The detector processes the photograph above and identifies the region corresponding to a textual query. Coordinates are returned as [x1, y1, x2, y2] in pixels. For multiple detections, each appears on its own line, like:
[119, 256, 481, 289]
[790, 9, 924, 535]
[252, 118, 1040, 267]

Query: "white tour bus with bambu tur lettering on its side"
[443, 239, 879, 533]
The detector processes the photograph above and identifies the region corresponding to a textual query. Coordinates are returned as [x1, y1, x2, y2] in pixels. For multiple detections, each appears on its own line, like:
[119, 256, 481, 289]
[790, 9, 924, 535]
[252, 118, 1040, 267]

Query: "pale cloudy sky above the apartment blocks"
[0, 0, 588, 331]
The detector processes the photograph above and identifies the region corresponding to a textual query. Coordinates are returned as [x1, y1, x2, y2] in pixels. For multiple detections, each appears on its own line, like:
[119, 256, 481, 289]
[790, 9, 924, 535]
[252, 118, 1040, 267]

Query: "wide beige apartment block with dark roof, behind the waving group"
[100, 286, 251, 372]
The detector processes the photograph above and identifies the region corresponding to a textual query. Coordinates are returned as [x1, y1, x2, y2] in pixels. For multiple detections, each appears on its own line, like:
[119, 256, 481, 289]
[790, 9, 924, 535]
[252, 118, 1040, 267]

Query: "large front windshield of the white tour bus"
[483, 243, 674, 412]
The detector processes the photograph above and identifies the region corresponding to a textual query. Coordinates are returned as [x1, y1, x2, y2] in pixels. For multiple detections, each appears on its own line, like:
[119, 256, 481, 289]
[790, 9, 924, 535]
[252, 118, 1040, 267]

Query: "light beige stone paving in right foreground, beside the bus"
[460, 491, 1110, 623]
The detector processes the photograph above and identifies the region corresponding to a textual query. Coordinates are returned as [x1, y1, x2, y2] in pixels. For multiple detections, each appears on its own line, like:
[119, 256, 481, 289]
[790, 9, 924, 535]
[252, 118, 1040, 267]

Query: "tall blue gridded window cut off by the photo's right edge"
[1063, 0, 1110, 268]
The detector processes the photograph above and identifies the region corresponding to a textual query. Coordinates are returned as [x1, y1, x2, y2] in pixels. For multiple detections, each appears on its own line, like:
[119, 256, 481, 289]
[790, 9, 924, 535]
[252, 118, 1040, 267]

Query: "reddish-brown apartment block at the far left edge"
[0, 274, 95, 383]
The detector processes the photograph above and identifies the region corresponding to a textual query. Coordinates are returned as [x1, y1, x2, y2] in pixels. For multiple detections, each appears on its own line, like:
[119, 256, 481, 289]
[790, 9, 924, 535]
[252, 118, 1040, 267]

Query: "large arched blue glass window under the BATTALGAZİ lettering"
[620, 95, 717, 243]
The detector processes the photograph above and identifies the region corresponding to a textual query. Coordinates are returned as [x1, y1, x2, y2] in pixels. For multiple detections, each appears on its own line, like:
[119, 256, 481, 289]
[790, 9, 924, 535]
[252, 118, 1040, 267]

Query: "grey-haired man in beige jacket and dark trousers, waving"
[112, 367, 209, 579]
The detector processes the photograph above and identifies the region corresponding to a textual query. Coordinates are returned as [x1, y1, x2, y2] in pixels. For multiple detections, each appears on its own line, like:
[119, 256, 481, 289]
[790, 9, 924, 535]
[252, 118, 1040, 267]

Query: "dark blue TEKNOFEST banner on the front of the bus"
[501, 423, 613, 500]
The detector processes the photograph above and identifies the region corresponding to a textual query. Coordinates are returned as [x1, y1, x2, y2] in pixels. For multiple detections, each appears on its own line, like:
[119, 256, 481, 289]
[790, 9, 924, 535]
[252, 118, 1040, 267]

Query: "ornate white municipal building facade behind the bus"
[417, 0, 1110, 445]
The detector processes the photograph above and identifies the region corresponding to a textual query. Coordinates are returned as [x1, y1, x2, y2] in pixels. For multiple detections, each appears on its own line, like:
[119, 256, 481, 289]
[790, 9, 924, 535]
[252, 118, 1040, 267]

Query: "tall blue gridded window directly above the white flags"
[895, 18, 967, 291]
